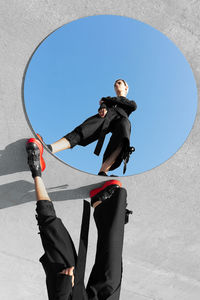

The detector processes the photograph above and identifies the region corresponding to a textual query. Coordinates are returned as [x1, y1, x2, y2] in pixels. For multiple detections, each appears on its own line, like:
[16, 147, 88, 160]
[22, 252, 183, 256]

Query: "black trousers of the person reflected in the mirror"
[64, 108, 131, 170]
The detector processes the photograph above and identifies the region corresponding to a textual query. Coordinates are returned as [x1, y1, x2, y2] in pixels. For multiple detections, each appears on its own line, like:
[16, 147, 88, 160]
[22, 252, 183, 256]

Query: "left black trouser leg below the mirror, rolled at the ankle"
[36, 200, 87, 300]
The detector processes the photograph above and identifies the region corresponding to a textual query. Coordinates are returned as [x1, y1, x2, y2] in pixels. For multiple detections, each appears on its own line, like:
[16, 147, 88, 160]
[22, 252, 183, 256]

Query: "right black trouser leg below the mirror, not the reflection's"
[86, 188, 127, 300]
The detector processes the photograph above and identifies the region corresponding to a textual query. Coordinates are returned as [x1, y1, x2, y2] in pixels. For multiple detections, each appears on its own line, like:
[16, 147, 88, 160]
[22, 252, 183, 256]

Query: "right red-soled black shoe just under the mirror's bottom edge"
[90, 180, 122, 206]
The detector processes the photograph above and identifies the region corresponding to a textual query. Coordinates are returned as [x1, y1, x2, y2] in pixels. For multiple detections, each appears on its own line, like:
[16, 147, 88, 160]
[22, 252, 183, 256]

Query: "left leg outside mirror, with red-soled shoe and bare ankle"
[26, 139, 77, 300]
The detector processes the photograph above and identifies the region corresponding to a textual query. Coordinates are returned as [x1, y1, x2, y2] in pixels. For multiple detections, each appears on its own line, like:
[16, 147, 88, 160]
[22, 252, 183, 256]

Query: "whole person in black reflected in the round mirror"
[47, 79, 137, 176]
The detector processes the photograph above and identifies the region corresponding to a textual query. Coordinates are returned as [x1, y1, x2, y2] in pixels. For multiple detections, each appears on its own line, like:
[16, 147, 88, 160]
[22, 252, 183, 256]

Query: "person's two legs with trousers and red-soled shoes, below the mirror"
[26, 138, 131, 300]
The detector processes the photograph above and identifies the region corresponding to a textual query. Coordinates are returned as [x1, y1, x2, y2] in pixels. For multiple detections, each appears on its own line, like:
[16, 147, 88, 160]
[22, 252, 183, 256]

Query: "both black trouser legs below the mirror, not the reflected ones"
[36, 188, 127, 300]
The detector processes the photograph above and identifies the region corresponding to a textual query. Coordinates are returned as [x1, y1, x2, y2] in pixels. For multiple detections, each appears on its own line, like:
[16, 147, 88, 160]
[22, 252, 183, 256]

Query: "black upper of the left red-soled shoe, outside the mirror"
[26, 141, 42, 178]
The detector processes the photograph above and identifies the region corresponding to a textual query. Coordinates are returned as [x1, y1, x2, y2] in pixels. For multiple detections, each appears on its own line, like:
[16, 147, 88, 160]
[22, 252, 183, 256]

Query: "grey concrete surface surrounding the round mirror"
[0, 0, 200, 300]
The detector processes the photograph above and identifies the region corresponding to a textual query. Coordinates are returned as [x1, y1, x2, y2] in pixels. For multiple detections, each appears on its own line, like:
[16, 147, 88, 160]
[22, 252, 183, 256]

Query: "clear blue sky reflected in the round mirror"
[24, 15, 197, 176]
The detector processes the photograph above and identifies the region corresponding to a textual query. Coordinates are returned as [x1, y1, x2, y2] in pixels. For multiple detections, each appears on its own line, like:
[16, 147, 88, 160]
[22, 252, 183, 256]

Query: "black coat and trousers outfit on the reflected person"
[65, 96, 137, 170]
